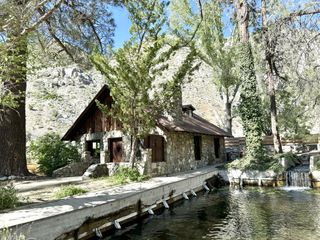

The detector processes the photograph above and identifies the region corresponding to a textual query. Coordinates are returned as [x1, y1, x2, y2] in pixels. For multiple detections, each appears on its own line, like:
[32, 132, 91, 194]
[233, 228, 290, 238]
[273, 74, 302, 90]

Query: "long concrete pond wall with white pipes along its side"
[0, 167, 225, 240]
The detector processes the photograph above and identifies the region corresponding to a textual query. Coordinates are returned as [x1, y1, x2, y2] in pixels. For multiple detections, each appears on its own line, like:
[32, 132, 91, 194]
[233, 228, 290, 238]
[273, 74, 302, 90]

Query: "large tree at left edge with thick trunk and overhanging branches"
[0, 0, 124, 176]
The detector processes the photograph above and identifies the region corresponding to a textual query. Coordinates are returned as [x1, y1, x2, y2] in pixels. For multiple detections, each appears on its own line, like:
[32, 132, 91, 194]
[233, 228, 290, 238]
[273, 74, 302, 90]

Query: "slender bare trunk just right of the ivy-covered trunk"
[261, 0, 282, 153]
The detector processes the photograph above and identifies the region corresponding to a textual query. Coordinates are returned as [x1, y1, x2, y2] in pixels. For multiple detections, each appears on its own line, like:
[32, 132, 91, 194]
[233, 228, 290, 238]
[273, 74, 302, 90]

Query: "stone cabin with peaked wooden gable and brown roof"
[62, 85, 230, 176]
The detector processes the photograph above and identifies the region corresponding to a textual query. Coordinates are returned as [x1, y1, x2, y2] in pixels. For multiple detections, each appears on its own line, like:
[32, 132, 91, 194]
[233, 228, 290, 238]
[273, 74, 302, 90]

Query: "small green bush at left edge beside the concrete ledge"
[0, 184, 19, 210]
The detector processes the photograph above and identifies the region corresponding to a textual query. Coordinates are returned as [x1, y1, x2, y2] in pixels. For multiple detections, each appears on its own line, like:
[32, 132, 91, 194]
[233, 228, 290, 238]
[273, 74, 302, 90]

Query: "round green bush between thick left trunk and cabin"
[28, 133, 80, 176]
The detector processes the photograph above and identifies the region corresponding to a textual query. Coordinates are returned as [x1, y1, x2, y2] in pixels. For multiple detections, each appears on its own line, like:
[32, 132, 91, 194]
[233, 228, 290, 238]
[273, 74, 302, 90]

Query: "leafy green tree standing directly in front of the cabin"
[92, 0, 199, 165]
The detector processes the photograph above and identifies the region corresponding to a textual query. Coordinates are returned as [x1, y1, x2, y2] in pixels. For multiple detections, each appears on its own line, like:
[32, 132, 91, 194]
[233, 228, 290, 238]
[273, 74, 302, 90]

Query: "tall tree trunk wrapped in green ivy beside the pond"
[234, 0, 263, 163]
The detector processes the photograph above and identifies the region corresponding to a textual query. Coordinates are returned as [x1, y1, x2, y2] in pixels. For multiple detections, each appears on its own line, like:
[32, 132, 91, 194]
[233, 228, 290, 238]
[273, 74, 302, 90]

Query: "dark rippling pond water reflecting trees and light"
[107, 188, 320, 240]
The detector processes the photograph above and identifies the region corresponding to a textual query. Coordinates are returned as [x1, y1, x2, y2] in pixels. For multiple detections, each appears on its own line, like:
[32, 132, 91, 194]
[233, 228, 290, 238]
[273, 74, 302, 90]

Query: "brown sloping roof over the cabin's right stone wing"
[158, 113, 232, 137]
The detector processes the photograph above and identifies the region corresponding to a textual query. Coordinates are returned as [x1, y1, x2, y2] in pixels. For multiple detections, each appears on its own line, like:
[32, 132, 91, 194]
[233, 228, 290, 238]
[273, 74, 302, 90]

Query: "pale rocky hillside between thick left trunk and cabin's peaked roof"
[26, 65, 106, 140]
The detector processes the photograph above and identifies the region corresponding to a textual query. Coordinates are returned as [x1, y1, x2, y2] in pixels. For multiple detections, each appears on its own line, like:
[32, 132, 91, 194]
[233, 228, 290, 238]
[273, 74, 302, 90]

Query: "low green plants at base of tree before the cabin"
[114, 167, 148, 184]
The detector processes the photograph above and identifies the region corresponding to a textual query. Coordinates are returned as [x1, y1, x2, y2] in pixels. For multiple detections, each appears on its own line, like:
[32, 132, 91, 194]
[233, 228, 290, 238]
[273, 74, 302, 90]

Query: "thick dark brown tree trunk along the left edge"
[0, 38, 28, 176]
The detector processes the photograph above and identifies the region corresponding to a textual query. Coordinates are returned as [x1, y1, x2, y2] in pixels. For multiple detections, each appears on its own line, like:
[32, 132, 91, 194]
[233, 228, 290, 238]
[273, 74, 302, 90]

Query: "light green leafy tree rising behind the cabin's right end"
[169, 0, 240, 133]
